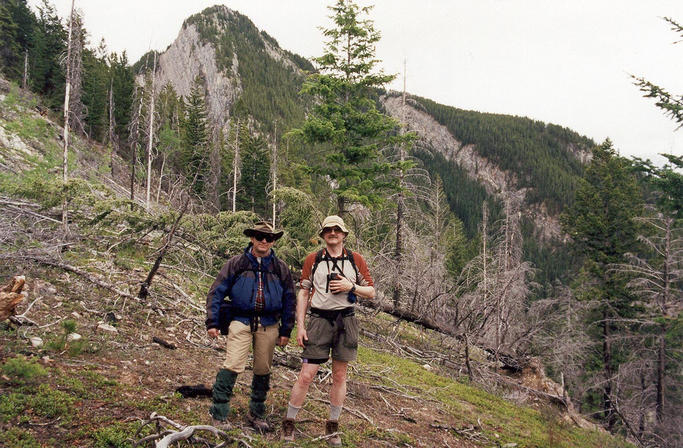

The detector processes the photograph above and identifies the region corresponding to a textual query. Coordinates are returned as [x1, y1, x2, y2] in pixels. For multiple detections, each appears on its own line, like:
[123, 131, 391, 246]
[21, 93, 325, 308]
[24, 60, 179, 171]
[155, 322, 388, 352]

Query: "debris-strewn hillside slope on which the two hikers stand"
[0, 81, 630, 448]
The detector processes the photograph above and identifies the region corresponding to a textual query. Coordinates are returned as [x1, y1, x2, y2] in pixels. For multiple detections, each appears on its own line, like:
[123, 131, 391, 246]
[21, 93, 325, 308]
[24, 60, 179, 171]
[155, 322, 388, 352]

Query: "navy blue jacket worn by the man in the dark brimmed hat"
[206, 244, 296, 337]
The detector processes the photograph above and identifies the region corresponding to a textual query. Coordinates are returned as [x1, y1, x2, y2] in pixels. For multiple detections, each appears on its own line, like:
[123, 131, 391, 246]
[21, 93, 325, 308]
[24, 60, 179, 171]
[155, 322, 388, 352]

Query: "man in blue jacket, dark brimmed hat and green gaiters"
[206, 222, 296, 432]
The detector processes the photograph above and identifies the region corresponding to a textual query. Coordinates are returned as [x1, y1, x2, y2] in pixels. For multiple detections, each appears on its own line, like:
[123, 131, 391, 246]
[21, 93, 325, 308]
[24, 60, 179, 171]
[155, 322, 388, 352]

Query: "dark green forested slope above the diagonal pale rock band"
[413, 97, 594, 214]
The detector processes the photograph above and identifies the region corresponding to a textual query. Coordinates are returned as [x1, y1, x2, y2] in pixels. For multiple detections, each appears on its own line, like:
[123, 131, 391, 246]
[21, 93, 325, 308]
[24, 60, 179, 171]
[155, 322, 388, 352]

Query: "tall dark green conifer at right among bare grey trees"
[562, 140, 642, 430]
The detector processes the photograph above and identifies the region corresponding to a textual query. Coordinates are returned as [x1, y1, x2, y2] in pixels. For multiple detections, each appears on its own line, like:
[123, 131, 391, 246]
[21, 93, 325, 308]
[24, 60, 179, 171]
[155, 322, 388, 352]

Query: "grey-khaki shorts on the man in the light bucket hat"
[301, 314, 358, 364]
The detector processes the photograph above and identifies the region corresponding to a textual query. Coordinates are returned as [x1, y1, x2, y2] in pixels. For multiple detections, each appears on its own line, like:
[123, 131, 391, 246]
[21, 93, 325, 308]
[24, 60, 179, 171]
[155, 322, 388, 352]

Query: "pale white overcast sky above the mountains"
[29, 0, 683, 163]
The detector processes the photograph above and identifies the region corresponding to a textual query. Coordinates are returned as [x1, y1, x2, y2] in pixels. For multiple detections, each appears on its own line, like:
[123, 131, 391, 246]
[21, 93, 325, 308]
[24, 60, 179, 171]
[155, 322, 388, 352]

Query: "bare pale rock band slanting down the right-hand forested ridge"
[381, 95, 568, 241]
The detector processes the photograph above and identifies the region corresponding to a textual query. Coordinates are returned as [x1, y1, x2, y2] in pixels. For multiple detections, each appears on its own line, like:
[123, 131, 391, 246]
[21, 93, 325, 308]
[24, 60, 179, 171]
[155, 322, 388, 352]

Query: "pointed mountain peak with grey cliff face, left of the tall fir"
[146, 5, 303, 127]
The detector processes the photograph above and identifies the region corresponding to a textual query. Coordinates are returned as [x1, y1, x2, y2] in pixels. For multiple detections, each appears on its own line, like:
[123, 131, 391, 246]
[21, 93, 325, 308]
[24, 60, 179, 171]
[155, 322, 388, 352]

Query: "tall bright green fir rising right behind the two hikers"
[292, 0, 410, 214]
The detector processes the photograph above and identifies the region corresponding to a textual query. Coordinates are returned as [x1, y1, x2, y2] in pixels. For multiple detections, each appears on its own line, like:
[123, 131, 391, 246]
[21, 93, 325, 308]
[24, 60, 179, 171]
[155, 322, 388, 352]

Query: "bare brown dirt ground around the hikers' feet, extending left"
[0, 270, 480, 447]
